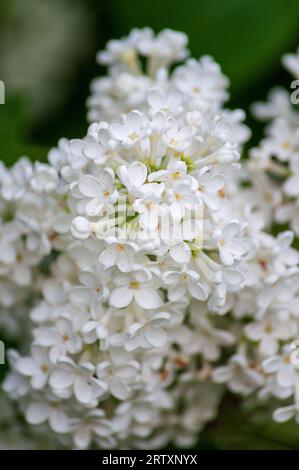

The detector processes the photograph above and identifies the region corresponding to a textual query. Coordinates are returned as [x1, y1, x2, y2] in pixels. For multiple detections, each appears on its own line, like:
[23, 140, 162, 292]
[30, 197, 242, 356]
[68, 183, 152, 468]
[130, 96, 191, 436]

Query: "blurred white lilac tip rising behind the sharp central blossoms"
[87, 28, 250, 144]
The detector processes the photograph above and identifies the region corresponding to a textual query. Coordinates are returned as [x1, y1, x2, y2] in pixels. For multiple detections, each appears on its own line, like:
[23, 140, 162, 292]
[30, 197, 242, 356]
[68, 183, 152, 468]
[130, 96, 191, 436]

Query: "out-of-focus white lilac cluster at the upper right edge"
[251, 47, 299, 236]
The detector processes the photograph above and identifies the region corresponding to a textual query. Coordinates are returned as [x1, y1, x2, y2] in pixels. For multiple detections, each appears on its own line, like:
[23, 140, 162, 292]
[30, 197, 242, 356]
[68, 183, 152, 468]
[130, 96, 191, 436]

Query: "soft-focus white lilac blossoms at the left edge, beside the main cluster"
[0, 158, 64, 338]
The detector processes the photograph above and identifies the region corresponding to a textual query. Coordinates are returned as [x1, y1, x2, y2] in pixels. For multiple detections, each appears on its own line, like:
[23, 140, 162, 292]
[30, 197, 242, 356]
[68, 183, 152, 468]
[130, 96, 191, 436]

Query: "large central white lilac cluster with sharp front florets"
[1, 29, 299, 448]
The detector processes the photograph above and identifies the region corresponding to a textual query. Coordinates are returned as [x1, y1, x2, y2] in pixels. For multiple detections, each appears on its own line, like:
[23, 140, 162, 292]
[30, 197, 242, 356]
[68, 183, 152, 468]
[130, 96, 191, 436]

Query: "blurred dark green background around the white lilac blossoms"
[0, 0, 299, 449]
